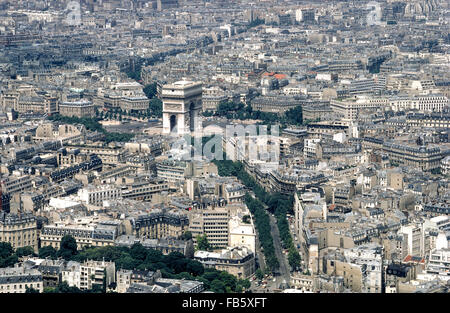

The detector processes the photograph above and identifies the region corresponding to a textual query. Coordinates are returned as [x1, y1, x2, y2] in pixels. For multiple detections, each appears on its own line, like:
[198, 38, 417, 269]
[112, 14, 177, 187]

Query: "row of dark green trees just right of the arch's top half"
[203, 102, 303, 128]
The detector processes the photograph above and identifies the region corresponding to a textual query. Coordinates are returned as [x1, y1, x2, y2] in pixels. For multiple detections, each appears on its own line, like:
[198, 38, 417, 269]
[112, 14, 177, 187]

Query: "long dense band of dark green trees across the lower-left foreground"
[39, 234, 250, 292]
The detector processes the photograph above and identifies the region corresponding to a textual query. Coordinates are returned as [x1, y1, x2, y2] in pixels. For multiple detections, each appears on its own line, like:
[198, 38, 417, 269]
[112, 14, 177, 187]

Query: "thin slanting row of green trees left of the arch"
[48, 114, 134, 143]
